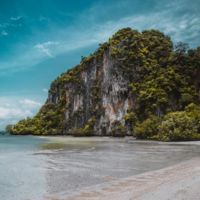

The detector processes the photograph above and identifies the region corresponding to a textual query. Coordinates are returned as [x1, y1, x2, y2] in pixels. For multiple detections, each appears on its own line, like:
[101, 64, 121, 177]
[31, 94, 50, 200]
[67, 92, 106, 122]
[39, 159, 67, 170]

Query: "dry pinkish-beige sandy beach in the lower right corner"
[66, 158, 200, 200]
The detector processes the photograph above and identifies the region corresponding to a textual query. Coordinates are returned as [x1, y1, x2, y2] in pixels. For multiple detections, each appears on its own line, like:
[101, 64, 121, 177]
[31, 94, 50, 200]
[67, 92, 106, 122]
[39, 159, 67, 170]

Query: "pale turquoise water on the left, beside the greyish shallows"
[0, 136, 46, 200]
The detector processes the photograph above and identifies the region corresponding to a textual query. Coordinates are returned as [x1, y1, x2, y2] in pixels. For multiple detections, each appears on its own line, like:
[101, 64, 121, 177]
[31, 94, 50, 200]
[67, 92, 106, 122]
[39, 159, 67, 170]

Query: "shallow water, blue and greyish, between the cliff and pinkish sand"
[0, 136, 200, 200]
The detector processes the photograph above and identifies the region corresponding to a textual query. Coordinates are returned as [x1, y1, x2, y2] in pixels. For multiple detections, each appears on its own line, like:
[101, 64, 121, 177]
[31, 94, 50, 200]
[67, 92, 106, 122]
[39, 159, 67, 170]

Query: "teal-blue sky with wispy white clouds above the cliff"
[0, 0, 200, 130]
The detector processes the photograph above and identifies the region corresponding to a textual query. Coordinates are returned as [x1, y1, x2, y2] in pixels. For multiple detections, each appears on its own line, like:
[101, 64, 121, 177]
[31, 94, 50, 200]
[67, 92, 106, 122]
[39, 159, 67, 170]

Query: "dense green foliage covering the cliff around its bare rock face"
[8, 28, 200, 141]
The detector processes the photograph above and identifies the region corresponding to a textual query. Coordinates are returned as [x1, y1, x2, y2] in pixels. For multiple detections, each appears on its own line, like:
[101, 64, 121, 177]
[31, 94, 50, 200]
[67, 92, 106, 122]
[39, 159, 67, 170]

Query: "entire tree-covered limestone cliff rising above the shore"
[7, 28, 200, 141]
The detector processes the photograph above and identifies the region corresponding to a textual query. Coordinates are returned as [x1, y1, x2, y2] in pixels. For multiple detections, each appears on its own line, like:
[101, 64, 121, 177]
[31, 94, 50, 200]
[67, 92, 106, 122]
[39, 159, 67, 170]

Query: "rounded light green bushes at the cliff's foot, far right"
[135, 104, 200, 141]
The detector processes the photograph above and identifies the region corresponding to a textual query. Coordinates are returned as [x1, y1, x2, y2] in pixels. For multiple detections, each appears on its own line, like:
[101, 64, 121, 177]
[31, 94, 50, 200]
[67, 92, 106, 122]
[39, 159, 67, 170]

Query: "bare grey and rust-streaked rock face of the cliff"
[47, 46, 133, 135]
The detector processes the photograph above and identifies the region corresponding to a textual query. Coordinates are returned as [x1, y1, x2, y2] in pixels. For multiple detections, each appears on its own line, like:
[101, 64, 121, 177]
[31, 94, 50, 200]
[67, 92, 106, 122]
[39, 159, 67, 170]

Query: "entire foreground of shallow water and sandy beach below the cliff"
[0, 136, 200, 200]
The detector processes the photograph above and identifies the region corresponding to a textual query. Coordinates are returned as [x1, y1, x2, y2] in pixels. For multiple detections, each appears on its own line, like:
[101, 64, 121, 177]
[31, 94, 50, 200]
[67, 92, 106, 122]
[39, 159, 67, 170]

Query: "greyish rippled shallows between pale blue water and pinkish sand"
[42, 137, 200, 199]
